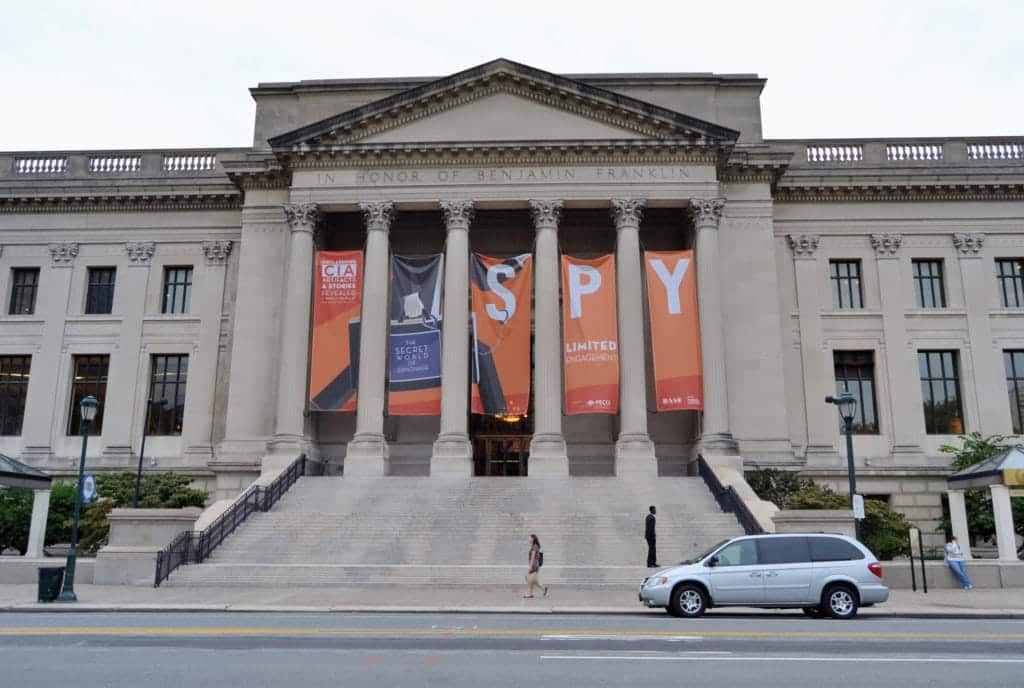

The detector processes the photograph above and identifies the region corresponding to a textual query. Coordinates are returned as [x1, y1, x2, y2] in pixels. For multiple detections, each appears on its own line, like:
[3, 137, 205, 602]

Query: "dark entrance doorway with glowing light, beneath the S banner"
[470, 414, 534, 477]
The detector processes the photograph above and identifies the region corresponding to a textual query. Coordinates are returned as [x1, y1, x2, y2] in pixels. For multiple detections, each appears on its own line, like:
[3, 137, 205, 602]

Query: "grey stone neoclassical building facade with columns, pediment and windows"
[0, 60, 1024, 544]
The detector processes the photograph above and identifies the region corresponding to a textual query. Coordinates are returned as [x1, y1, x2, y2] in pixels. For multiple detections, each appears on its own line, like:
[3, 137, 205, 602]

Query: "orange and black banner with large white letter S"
[470, 253, 534, 416]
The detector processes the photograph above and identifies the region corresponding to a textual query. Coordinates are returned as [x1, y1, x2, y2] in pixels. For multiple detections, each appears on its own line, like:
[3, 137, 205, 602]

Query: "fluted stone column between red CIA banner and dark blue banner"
[344, 201, 394, 475]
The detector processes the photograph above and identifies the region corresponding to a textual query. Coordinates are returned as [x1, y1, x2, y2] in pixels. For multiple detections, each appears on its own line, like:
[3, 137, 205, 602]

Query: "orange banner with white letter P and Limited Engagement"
[562, 255, 618, 416]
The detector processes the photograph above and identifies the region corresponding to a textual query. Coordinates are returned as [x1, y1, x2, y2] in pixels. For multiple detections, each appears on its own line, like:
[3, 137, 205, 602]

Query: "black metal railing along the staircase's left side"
[153, 456, 306, 588]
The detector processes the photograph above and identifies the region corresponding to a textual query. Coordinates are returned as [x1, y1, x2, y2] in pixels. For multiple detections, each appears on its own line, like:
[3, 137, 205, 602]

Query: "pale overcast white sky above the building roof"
[0, 0, 1024, 151]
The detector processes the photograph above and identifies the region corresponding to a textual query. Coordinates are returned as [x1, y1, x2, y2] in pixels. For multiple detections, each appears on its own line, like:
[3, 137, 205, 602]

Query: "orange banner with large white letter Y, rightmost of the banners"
[644, 251, 703, 411]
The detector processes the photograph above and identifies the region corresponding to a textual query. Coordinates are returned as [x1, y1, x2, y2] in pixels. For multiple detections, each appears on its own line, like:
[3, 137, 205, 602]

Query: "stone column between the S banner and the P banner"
[527, 201, 569, 477]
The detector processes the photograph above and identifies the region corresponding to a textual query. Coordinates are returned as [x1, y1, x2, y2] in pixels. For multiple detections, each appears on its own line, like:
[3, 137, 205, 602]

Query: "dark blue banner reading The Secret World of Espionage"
[387, 253, 444, 416]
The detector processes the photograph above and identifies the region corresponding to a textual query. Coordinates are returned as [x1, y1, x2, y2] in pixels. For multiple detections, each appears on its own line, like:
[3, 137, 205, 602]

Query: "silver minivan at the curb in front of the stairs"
[640, 532, 889, 618]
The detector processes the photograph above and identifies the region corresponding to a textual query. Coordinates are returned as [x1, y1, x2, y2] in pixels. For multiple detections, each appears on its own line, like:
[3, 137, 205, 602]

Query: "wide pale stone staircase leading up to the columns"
[165, 477, 742, 587]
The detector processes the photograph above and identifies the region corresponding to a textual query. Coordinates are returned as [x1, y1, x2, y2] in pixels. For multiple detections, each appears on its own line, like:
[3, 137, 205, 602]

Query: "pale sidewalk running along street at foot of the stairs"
[0, 585, 1024, 618]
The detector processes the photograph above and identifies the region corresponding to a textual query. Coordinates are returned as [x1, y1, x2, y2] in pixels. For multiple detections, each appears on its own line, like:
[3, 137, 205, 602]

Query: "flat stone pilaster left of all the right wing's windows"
[786, 234, 839, 459]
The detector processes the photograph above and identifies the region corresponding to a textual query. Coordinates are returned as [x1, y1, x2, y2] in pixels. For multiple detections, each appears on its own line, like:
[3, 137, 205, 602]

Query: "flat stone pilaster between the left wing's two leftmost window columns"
[22, 243, 78, 465]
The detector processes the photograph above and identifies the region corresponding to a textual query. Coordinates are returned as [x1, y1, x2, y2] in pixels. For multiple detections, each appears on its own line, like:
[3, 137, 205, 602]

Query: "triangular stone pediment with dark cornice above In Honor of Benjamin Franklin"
[269, 59, 739, 153]
